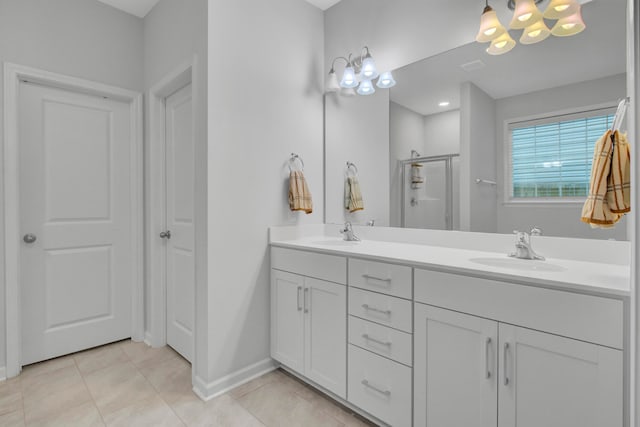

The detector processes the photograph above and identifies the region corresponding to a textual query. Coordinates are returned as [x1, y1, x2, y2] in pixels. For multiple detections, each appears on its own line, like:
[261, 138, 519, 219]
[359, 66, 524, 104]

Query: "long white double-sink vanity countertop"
[271, 236, 631, 297]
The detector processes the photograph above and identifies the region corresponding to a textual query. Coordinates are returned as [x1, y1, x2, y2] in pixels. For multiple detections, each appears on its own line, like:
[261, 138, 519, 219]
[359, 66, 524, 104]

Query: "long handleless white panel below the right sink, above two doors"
[415, 269, 624, 349]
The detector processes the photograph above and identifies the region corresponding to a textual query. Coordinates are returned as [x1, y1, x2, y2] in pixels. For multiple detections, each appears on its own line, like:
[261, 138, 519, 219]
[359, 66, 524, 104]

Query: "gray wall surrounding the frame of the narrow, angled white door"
[144, 0, 209, 382]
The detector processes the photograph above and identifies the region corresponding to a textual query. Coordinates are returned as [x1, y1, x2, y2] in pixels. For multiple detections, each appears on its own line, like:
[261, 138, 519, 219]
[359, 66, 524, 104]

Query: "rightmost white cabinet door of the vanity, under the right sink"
[498, 324, 623, 427]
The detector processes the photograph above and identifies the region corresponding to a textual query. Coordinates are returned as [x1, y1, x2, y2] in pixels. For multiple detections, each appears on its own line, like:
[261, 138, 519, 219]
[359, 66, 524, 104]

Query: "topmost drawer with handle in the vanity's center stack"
[349, 259, 413, 299]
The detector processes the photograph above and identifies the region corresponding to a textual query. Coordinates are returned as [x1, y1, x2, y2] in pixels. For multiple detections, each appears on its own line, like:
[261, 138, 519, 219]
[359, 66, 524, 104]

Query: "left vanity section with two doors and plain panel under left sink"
[271, 248, 347, 399]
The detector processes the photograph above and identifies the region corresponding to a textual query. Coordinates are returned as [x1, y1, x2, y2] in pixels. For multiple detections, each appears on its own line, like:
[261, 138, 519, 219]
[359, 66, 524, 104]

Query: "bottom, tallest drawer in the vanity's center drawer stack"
[347, 345, 411, 427]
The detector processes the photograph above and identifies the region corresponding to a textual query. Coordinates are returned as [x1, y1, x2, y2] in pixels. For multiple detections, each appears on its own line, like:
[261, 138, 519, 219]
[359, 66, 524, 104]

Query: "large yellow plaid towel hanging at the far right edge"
[580, 131, 630, 228]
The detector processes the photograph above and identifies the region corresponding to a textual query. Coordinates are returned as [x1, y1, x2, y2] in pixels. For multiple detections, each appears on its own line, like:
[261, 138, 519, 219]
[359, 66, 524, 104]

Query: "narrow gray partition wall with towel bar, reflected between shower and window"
[460, 82, 497, 233]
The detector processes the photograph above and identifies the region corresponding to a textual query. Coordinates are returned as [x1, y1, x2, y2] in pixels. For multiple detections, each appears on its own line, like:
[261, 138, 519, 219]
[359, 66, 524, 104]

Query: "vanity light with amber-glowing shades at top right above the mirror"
[476, 0, 586, 55]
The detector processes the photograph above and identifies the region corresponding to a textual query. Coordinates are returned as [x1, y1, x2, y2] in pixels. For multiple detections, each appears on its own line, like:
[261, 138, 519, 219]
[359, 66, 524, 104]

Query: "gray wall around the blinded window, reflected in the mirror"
[495, 74, 627, 240]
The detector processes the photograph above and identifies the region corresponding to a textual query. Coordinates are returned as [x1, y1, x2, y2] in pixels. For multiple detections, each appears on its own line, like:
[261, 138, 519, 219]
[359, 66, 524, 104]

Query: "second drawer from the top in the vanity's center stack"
[349, 287, 412, 333]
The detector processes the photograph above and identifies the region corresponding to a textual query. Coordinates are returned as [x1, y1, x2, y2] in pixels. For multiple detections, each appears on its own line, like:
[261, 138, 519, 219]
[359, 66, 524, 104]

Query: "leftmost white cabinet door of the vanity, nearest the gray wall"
[271, 270, 304, 373]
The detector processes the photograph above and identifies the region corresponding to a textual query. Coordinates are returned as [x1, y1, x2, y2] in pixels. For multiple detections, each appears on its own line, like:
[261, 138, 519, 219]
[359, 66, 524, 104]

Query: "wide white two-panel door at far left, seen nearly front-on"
[18, 83, 133, 365]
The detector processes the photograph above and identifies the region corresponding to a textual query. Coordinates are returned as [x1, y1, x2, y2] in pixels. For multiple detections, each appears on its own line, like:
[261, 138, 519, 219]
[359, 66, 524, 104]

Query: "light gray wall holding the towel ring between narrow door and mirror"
[206, 0, 324, 390]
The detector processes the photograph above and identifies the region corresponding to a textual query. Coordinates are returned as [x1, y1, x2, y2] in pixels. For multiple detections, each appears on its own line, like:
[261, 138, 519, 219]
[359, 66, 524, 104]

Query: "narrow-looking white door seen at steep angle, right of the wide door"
[162, 85, 195, 362]
